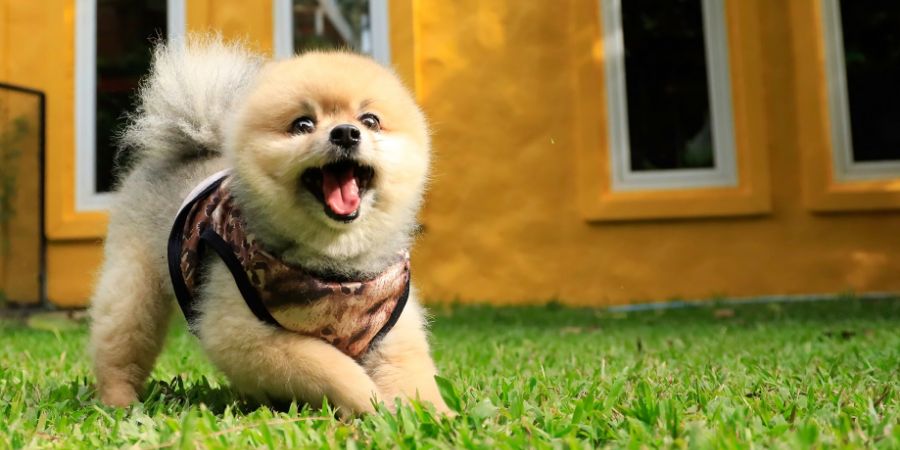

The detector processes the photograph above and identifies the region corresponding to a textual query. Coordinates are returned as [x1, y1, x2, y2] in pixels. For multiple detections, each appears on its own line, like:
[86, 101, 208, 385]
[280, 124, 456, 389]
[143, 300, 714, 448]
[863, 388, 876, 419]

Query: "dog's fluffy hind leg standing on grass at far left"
[90, 236, 173, 406]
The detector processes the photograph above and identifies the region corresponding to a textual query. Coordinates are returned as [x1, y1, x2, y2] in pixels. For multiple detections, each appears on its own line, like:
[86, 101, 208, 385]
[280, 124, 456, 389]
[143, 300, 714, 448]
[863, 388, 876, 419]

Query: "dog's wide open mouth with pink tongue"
[300, 159, 375, 222]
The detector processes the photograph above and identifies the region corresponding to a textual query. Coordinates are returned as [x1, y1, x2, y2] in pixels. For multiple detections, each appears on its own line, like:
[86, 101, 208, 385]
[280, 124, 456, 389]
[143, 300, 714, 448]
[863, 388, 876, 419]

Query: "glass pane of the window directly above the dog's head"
[292, 0, 371, 53]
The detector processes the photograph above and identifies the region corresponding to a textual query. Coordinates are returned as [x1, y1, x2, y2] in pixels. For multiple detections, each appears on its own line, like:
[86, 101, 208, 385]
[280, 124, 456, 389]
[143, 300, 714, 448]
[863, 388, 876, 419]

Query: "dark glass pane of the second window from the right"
[622, 0, 715, 171]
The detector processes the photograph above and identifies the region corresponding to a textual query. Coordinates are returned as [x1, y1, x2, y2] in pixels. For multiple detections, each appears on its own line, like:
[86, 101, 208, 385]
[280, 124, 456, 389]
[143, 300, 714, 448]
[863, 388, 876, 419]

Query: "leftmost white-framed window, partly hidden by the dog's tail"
[75, 0, 185, 211]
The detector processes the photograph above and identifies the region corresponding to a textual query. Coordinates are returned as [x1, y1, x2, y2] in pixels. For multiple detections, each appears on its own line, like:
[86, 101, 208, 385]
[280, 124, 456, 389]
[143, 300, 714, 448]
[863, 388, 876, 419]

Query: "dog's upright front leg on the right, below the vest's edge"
[364, 294, 450, 413]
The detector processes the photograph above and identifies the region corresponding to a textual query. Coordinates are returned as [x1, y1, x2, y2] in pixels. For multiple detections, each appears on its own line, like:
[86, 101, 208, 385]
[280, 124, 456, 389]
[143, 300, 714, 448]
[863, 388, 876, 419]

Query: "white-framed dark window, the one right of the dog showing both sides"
[601, 0, 737, 191]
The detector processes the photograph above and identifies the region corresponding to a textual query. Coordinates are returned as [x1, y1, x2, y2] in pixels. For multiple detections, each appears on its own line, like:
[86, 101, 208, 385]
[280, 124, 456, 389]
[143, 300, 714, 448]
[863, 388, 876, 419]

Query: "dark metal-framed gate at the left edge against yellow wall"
[0, 83, 45, 304]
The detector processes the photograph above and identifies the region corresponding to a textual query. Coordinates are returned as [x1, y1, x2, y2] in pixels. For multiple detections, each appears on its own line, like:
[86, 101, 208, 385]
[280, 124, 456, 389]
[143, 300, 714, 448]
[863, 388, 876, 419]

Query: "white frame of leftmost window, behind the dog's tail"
[75, 0, 186, 211]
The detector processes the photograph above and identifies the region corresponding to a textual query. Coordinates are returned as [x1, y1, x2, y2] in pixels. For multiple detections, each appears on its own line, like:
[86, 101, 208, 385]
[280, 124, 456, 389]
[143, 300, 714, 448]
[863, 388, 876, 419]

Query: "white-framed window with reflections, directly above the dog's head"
[274, 0, 391, 64]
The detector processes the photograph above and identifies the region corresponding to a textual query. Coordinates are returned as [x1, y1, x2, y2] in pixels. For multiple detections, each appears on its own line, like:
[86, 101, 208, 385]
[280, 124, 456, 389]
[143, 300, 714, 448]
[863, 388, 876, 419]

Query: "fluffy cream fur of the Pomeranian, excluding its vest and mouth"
[90, 38, 447, 414]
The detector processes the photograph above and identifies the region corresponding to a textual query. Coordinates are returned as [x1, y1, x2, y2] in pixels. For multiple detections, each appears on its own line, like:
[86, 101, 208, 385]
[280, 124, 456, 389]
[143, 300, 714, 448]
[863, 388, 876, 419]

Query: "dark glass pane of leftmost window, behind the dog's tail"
[96, 0, 166, 192]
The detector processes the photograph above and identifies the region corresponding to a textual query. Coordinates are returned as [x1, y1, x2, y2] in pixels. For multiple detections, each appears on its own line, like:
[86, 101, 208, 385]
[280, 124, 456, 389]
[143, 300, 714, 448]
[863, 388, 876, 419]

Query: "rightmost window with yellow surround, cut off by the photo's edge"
[787, 0, 900, 212]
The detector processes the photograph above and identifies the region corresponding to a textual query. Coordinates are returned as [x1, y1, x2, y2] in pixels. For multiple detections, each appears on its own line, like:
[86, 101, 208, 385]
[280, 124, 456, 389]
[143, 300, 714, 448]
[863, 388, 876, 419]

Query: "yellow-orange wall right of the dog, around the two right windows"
[414, 0, 900, 305]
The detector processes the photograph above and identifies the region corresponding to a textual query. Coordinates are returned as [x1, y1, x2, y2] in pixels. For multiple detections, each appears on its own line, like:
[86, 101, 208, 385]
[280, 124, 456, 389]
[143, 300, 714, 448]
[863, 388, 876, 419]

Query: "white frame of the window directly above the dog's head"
[272, 0, 391, 66]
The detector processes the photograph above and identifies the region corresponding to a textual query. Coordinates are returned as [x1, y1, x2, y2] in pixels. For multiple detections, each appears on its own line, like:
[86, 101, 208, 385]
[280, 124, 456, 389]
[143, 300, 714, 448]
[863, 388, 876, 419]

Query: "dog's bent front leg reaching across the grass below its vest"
[198, 262, 381, 416]
